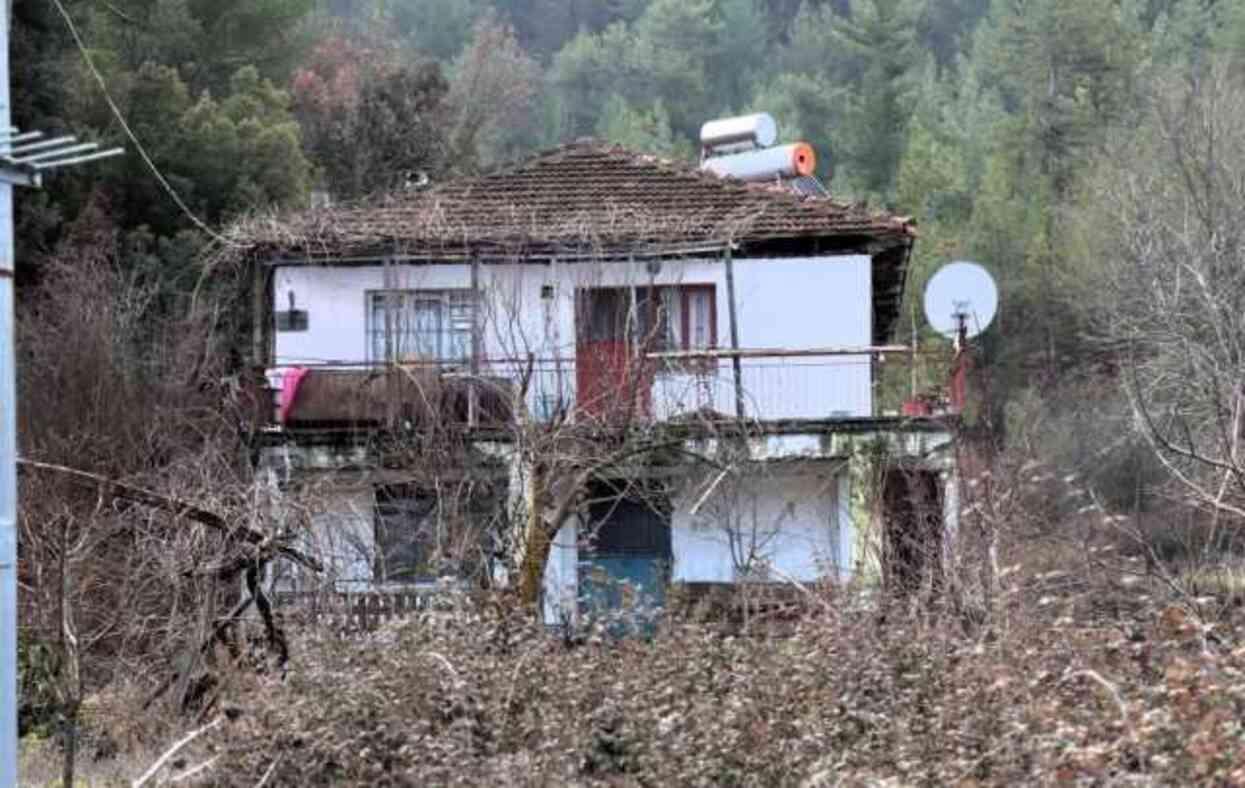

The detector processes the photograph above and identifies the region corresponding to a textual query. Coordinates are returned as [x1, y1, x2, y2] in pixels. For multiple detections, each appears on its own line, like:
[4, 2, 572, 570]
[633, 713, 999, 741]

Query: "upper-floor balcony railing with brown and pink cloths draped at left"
[260, 347, 936, 428]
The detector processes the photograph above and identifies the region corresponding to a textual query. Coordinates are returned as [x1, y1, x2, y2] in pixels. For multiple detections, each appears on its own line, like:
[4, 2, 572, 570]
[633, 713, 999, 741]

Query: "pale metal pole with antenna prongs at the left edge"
[0, 0, 125, 788]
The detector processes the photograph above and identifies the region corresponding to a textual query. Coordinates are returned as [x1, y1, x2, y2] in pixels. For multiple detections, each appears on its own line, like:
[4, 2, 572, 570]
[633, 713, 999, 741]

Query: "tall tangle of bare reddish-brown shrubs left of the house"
[19, 207, 271, 776]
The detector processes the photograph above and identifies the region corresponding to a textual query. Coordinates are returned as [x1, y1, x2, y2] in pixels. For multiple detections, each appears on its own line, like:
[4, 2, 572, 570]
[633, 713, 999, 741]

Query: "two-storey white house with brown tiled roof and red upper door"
[235, 141, 956, 620]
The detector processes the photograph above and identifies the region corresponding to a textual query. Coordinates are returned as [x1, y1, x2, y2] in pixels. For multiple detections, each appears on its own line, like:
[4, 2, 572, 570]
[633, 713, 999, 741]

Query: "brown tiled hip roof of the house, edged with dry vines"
[224, 141, 914, 259]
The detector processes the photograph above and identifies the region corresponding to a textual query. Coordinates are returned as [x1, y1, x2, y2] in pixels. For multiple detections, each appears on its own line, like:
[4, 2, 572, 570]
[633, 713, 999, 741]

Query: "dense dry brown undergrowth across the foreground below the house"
[155, 575, 1245, 786]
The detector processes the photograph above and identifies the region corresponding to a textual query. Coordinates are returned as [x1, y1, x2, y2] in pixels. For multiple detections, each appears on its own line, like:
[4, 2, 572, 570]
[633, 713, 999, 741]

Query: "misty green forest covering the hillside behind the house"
[12, 0, 1245, 515]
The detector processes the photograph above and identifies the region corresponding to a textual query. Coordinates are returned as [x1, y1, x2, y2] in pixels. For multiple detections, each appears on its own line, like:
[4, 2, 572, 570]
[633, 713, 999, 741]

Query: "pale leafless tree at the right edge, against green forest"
[1072, 63, 1245, 540]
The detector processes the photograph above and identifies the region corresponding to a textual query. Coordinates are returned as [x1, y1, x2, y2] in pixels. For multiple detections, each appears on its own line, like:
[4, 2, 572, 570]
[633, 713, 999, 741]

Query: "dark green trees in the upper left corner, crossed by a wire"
[14, 0, 312, 279]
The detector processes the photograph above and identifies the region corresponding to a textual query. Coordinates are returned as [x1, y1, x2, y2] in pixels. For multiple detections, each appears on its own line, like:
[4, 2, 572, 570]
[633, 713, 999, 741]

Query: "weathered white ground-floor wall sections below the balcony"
[263, 423, 959, 602]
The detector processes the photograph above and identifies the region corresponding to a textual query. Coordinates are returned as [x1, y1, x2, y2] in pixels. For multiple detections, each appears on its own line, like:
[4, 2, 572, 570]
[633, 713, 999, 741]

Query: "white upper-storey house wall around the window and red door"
[273, 255, 873, 420]
